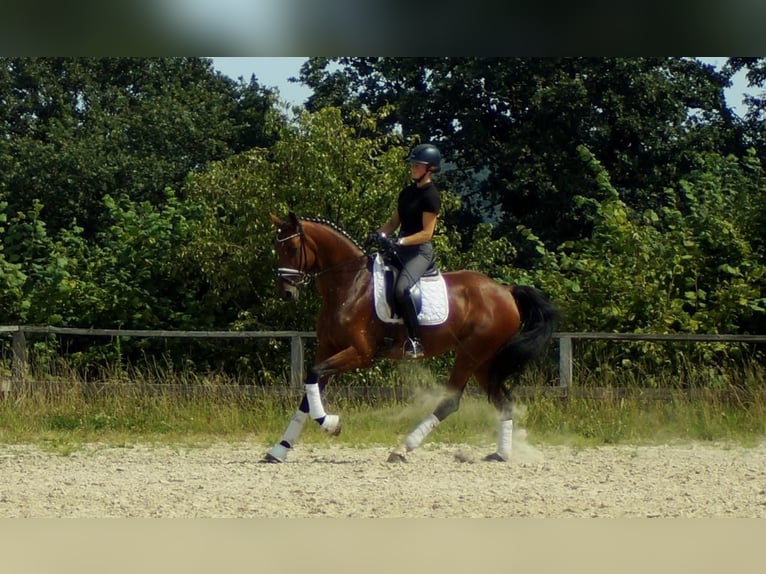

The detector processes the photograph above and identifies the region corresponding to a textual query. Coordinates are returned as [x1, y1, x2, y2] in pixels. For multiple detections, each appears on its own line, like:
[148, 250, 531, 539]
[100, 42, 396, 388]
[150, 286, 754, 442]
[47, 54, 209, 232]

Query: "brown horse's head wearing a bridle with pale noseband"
[271, 212, 316, 300]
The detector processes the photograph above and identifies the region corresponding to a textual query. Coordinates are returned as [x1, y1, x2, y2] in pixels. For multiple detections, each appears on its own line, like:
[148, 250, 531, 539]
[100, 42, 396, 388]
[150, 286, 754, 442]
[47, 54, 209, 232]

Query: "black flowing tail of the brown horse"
[487, 285, 558, 400]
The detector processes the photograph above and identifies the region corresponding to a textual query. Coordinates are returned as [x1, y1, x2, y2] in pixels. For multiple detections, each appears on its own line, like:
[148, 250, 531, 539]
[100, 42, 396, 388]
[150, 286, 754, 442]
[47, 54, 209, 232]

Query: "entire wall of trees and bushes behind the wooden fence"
[0, 58, 766, 384]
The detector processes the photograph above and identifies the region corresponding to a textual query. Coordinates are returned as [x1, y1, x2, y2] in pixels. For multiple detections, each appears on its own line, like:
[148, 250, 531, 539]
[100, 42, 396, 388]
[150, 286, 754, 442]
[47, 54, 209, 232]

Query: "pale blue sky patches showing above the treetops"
[212, 57, 752, 117]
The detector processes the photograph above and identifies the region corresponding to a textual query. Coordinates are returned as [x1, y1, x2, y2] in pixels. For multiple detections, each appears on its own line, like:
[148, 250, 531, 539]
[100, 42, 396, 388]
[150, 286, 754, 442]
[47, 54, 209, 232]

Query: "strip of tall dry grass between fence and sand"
[0, 356, 766, 455]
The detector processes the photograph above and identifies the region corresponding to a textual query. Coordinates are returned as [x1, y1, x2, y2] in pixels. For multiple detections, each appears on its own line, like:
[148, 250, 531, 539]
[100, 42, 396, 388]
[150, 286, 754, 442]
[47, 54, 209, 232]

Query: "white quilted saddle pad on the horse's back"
[372, 253, 449, 325]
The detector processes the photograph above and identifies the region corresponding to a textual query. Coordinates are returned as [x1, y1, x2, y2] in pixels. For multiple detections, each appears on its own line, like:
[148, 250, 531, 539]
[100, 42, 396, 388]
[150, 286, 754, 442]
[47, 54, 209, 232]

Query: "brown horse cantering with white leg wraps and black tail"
[264, 213, 556, 462]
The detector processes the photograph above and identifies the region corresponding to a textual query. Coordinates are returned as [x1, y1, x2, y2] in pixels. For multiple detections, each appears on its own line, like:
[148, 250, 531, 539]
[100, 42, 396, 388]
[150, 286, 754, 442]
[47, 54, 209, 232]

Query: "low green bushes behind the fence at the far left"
[0, 191, 202, 328]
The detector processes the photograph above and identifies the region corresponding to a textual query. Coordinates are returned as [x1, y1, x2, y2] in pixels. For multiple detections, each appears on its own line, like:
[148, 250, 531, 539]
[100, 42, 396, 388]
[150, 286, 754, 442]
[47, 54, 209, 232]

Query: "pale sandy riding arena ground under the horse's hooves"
[0, 436, 766, 518]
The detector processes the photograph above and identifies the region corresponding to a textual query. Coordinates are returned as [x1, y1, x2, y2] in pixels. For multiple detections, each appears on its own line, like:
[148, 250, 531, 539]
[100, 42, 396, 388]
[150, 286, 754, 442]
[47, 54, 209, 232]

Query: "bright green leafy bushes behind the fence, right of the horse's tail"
[512, 148, 766, 333]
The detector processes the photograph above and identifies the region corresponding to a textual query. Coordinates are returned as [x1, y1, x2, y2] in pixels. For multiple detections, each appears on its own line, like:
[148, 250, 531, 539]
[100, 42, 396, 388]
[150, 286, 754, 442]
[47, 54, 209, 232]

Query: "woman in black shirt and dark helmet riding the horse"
[378, 144, 441, 359]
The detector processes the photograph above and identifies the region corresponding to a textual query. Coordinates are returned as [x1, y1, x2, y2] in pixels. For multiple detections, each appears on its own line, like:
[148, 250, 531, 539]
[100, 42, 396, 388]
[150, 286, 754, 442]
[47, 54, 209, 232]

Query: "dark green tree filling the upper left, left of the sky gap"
[0, 58, 274, 237]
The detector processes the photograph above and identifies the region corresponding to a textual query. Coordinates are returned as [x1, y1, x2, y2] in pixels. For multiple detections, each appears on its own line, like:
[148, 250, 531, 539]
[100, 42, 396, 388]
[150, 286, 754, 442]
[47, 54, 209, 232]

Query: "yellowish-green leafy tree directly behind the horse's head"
[184, 109, 406, 329]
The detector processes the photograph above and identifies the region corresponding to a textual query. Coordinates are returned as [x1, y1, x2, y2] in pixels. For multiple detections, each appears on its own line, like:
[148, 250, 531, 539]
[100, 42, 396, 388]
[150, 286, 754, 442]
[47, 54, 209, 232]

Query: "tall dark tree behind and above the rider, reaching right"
[301, 57, 744, 254]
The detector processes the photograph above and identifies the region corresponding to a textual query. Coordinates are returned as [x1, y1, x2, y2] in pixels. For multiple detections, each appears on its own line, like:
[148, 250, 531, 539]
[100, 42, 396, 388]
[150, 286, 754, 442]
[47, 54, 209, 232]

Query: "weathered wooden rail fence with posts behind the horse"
[0, 325, 766, 391]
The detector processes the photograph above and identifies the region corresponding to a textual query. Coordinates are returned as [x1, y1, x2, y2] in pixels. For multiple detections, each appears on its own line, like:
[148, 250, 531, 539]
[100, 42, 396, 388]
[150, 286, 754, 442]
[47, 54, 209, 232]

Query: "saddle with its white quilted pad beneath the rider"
[371, 253, 449, 325]
